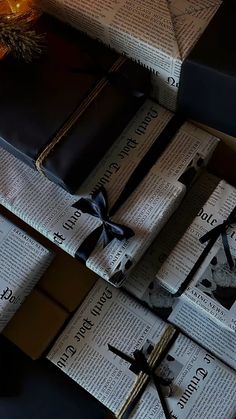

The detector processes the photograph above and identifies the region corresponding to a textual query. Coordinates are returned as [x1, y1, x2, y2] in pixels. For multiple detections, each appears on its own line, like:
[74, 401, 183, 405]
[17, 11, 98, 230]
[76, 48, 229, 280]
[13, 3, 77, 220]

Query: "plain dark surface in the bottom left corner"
[0, 336, 108, 419]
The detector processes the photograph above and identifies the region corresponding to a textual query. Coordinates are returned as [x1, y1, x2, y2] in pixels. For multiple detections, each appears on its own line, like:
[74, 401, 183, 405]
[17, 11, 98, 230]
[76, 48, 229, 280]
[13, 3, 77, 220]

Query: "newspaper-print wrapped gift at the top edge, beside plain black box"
[40, 0, 222, 110]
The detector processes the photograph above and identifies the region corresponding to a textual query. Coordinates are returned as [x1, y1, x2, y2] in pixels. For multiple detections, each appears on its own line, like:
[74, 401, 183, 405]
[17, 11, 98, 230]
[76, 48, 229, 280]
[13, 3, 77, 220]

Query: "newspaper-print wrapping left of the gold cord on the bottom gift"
[47, 281, 174, 418]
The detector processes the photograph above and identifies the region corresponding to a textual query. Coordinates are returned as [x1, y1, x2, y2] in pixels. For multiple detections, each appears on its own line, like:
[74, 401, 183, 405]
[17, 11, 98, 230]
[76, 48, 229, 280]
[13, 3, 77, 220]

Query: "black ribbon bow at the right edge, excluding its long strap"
[199, 207, 236, 270]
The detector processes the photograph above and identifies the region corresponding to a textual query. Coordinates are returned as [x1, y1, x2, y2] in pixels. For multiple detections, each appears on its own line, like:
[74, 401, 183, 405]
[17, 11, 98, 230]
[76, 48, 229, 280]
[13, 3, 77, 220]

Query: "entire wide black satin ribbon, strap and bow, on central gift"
[72, 114, 185, 263]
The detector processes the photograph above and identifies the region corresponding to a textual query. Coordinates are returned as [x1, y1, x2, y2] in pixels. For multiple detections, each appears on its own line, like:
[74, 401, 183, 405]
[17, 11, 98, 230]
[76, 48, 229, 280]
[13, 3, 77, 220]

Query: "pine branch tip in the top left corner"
[0, 14, 45, 63]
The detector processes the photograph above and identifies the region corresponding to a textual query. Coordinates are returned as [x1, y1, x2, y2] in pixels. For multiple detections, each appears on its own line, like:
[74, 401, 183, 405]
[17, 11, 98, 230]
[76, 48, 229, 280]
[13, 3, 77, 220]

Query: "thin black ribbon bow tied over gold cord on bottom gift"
[108, 339, 172, 419]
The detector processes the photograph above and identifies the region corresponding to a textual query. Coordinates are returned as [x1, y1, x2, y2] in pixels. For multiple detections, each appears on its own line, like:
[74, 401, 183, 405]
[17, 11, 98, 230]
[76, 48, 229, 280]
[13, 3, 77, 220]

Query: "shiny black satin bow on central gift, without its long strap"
[72, 187, 134, 263]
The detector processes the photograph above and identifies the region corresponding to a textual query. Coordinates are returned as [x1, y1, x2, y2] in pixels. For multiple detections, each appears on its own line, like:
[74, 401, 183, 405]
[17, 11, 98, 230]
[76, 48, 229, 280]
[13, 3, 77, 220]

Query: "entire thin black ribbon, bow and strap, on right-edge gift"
[175, 207, 236, 297]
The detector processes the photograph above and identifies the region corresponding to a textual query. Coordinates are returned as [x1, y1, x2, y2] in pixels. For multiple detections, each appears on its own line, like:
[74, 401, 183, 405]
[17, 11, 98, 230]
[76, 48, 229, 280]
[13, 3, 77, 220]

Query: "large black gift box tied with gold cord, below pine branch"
[0, 15, 150, 193]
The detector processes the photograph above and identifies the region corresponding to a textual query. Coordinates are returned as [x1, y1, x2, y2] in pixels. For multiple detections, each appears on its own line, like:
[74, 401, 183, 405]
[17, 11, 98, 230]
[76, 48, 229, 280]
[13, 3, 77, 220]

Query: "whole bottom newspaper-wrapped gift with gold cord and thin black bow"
[47, 281, 236, 419]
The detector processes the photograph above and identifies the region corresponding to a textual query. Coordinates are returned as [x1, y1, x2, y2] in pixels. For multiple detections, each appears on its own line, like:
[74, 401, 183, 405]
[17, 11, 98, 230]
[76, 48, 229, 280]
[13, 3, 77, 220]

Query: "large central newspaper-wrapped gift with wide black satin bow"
[0, 100, 218, 286]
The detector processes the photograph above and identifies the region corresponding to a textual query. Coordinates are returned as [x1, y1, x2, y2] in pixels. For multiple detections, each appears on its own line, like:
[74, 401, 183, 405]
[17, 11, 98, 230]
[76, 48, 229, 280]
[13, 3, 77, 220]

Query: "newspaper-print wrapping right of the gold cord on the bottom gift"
[129, 334, 236, 419]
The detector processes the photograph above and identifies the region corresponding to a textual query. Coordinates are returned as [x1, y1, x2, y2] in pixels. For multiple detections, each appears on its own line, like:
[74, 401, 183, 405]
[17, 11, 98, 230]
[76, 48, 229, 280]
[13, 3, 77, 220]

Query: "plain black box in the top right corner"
[178, 0, 236, 136]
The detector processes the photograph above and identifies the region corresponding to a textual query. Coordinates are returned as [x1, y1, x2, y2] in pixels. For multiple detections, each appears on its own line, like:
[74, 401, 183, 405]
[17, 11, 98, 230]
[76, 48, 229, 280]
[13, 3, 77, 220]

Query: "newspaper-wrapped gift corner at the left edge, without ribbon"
[0, 215, 53, 331]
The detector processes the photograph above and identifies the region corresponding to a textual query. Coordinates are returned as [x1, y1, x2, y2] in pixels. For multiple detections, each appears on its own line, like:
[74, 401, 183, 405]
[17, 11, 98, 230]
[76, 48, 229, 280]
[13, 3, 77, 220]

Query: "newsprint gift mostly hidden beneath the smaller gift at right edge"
[124, 172, 236, 369]
